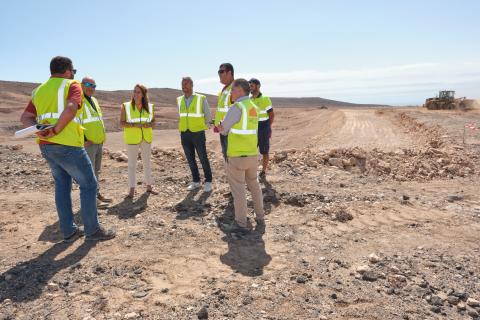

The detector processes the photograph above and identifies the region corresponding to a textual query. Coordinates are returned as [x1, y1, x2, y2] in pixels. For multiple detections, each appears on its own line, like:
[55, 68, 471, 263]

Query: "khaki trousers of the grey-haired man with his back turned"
[227, 156, 264, 227]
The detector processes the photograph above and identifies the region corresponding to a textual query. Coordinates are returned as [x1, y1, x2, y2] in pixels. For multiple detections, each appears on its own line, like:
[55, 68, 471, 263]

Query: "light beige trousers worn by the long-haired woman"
[127, 140, 153, 188]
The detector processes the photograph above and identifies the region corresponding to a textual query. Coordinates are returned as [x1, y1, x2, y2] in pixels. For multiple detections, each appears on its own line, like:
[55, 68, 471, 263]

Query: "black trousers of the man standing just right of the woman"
[180, 130, 212, 182]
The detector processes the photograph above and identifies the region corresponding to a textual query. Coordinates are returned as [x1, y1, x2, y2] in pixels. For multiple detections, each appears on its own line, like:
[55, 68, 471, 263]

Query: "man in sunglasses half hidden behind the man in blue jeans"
[82, 77, 112, 202]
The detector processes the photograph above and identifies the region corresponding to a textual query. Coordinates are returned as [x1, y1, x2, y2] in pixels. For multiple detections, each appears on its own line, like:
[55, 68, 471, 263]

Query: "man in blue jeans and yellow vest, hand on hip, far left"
[20, 56, 115, 242]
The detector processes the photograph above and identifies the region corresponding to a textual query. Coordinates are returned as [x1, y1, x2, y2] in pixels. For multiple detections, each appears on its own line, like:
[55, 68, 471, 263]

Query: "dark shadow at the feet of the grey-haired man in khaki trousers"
[216, 198, 272, 277]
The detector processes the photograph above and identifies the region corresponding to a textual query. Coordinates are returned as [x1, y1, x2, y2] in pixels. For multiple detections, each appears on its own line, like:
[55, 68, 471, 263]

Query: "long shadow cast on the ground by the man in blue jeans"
[0, 240, 96, 302]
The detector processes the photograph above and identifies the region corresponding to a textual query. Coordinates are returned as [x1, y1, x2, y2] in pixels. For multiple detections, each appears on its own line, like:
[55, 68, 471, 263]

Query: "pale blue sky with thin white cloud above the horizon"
[0, 0, 480, 104]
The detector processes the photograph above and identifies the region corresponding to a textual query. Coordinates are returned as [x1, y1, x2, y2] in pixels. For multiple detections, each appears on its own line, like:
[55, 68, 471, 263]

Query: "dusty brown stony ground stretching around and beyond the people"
[0, 81, 480, 320]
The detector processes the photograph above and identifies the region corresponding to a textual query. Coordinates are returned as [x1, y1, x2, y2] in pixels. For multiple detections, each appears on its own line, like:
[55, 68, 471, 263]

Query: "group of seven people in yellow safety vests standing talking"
[21, 56, 274, 242]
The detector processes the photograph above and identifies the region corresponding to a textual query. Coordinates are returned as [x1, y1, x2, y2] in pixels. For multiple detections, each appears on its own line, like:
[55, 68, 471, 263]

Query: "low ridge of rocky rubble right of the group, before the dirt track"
[273, 148, 477, 181]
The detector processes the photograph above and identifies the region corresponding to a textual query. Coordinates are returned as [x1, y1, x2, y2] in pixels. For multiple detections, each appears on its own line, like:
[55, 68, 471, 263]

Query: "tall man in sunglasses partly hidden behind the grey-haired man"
[215, 63, 234, 160]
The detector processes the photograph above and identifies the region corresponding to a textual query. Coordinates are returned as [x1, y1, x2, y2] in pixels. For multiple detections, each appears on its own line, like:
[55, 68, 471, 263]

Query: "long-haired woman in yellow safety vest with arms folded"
[120, 84, 157, 198]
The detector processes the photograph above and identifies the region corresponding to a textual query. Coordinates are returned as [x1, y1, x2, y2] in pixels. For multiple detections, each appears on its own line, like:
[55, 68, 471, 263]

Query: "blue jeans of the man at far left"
[40, 144, 100, 238]
